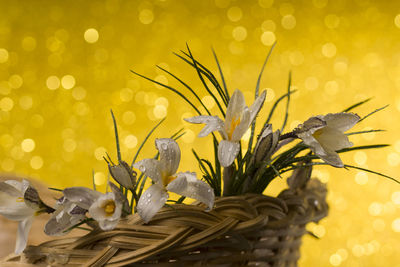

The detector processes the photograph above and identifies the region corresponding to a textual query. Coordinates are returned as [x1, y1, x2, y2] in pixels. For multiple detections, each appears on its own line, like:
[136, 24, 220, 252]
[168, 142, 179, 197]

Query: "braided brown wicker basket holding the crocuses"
[1, 172, 328, 266]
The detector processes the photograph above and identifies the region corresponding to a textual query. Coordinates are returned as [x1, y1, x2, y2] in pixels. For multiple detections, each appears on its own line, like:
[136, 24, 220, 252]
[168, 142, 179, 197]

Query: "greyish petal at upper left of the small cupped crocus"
[63, 187, 101, 209]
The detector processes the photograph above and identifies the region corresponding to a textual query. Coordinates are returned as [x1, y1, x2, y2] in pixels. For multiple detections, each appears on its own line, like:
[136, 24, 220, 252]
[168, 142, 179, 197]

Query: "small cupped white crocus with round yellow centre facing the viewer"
[63, 183, 125, 231]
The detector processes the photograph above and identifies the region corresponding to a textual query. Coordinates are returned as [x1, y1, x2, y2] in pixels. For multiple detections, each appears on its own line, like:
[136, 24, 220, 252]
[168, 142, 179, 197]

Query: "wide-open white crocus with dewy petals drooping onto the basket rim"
[134, 138, 214, 223]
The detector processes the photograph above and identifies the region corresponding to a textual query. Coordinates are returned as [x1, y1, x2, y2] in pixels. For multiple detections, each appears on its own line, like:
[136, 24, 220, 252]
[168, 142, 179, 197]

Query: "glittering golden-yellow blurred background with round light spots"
[0, 0, 400, 267]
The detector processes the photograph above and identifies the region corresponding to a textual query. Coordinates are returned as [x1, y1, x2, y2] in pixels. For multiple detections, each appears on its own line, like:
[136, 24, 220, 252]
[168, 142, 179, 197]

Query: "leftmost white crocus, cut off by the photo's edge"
[0, 180, 38, 254]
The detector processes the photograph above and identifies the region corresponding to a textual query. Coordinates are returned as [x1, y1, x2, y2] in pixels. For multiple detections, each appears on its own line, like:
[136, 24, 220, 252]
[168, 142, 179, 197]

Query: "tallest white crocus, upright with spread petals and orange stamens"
[185, 90, 266, 167]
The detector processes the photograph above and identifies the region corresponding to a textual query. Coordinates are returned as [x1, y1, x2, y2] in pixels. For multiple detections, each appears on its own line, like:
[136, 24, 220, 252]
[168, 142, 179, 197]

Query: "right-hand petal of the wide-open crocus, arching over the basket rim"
[167, 172, 215, 213]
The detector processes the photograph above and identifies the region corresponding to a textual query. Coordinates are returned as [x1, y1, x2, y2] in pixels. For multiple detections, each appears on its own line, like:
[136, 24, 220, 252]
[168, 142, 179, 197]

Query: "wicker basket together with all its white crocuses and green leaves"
[0, 47, 398, 266]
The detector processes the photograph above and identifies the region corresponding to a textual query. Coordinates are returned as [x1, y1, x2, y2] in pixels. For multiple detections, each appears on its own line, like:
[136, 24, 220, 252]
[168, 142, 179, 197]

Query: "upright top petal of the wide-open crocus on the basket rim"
[156, 138, 181, 175]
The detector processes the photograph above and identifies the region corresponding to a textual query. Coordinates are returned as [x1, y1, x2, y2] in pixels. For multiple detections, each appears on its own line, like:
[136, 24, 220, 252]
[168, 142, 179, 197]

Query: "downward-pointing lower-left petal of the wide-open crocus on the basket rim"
[136, 184, 169, 223]
